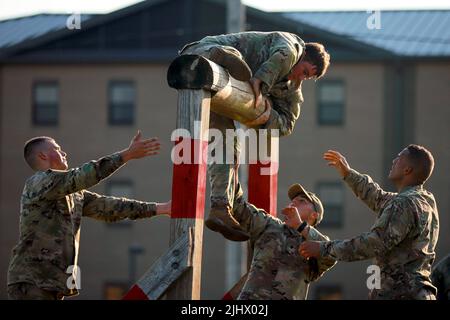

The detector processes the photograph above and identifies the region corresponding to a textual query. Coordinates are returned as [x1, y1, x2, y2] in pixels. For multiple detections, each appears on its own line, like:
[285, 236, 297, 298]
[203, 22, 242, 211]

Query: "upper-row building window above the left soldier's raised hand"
[109, 81, 136, 125]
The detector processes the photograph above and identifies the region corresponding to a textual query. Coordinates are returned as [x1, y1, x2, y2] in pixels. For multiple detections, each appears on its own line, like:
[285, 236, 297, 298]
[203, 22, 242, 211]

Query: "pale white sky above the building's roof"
[0, 0, 450, 20]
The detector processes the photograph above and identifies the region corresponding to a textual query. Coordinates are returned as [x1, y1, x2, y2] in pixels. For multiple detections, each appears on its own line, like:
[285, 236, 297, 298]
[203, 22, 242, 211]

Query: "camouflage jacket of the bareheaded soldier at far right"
[321, 170, 439, 299]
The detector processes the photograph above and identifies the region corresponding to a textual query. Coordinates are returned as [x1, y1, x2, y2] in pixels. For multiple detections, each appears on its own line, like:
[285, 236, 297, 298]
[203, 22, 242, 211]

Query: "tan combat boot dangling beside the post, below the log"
[205, 207, 250, 241]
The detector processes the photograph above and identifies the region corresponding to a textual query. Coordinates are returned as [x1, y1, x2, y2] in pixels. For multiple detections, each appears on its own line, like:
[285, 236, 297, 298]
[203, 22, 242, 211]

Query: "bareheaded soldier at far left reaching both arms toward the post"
[8, 133, 170, 300]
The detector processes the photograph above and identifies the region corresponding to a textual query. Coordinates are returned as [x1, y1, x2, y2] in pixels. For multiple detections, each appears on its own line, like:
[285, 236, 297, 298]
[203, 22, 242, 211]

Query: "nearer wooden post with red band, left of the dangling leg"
[167, 89, 211, 300]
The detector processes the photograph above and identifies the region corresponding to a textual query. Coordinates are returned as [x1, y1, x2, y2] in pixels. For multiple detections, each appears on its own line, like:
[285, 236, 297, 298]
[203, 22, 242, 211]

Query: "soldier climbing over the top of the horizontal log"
[180, 32, 330, 241]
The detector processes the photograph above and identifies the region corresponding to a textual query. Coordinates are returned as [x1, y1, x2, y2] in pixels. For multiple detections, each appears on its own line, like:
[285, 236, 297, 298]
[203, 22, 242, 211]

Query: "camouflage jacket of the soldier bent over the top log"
[189, 32, 305, 136]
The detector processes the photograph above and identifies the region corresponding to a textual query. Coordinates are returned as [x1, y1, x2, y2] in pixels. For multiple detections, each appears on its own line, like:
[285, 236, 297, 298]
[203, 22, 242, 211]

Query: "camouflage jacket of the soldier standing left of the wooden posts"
[8, 153, 156, 295]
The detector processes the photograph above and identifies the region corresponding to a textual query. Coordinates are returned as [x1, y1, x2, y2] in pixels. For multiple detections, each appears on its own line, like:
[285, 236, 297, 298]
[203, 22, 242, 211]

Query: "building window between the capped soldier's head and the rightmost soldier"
[317, 182, 344, 228]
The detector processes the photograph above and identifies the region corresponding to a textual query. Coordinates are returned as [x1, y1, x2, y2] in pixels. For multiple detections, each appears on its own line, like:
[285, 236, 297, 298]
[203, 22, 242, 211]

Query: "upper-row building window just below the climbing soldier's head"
[317, 80, 345, 125]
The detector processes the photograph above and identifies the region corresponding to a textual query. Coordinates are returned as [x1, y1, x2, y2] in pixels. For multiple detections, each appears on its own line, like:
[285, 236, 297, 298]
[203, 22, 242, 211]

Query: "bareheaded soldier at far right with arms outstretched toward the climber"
[299, 145, 439, 300]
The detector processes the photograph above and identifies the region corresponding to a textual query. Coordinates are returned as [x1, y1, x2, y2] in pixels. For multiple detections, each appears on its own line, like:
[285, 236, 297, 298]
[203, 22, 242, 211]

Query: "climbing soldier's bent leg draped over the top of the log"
[179, 41, 252, 81]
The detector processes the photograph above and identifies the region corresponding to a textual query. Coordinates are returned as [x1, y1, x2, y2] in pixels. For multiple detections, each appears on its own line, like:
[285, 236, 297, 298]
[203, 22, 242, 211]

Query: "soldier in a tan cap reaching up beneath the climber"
[225, 180, 336, 300]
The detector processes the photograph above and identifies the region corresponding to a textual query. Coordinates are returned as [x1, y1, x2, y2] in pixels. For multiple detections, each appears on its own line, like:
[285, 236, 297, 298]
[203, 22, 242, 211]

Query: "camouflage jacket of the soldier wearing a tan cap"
[234, 198, 336, 300]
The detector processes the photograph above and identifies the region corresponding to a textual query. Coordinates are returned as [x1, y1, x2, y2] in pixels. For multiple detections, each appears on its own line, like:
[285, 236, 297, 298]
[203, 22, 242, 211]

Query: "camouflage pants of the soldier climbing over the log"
[179, 42, 242, 209]
